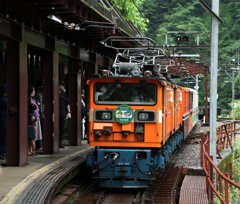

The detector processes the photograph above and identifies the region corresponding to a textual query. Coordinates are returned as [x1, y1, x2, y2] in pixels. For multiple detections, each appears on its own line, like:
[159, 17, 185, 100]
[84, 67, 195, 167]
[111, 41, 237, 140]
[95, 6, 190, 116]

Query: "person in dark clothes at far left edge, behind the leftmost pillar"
[0, 83, 7, 159]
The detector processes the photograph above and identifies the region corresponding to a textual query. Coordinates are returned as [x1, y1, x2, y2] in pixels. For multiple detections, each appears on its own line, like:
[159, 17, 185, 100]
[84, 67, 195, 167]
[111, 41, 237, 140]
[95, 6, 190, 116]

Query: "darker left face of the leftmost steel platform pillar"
[7, 42, 20, 166]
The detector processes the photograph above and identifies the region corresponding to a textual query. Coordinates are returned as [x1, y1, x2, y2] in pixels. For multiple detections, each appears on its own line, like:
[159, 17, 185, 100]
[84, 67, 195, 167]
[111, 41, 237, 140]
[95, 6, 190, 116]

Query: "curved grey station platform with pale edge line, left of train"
[0, 140, 94, 204]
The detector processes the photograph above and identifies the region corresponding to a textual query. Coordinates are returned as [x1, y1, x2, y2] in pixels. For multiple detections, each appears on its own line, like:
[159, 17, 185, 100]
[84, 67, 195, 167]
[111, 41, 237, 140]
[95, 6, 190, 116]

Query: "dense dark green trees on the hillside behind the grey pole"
[142, 0, 240, 109]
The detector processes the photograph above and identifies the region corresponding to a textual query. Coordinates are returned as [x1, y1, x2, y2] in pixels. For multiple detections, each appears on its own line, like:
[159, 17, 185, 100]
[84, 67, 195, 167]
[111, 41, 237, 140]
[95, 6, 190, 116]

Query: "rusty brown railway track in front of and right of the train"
[72, 166, 181, 204]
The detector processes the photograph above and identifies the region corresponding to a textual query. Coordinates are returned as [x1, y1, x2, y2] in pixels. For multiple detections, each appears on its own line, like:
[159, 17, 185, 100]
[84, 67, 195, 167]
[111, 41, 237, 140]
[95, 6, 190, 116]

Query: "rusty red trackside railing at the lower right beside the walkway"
[201, 121, 240, 204]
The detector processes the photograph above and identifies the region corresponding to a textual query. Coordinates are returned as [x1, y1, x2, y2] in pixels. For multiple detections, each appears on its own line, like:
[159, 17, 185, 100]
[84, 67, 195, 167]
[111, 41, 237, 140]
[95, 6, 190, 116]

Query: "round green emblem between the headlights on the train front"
[115, 105, 133, 124]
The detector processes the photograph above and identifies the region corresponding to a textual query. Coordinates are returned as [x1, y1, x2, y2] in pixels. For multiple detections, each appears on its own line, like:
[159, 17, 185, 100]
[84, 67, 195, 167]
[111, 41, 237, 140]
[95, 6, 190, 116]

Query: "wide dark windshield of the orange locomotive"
[94, 82, 157, 105]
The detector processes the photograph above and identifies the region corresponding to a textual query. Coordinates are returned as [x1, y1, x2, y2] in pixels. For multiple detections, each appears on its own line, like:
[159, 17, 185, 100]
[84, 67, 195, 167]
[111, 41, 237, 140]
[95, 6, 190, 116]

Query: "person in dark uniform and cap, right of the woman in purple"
[59, 81, 71, 148]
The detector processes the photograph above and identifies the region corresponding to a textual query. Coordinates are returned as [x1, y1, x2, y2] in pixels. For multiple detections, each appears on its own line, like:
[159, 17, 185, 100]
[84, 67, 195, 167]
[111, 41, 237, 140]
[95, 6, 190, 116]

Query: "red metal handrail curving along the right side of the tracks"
[201, 121, 240, 204]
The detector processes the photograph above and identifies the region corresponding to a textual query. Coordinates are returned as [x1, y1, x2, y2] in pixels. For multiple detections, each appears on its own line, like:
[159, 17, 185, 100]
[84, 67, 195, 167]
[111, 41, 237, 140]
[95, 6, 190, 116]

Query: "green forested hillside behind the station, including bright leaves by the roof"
[110, 0, 240, 113]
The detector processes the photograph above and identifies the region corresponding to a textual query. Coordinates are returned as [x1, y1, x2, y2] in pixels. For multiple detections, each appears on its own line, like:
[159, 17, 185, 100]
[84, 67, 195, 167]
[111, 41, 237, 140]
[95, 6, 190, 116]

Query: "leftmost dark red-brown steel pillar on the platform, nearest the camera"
[7, 32, 28, 166]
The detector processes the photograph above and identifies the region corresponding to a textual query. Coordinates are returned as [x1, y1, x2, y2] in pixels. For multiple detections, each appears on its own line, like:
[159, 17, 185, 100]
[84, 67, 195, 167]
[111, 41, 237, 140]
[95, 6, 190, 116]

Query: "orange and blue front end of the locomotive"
[87, 78, 182, 188]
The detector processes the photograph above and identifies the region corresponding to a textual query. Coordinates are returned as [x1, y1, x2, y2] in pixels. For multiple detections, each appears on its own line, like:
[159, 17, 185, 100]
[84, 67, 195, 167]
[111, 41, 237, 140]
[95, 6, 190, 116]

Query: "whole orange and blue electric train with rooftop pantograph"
[86, 39, 198, 188]
